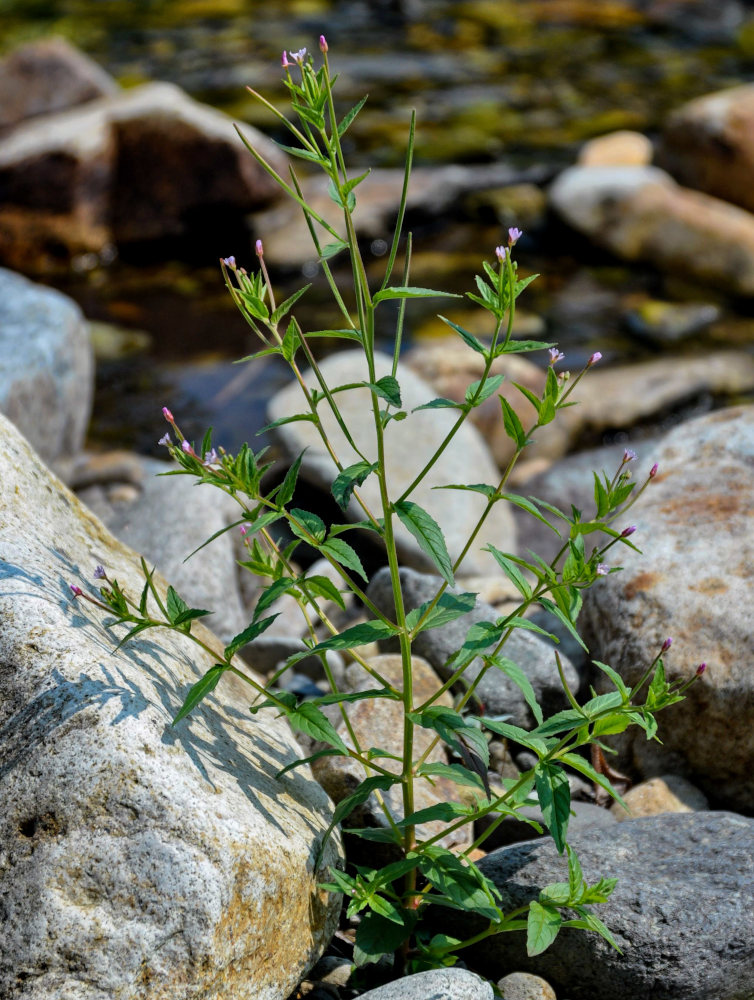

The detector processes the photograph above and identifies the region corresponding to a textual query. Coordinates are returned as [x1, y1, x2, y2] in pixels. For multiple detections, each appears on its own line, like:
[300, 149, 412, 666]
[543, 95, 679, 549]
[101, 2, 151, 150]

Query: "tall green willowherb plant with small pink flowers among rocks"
[72, 36, 704, 984]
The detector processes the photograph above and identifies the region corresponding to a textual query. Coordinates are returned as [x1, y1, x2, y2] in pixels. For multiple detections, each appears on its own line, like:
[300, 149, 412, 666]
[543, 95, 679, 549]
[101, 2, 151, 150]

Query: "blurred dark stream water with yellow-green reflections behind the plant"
[0, 0, 754, 453]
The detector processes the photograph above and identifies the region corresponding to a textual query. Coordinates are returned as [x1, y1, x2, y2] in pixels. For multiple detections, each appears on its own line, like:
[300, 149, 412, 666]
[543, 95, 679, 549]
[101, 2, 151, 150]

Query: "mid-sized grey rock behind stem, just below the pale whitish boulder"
[367, 569, 579, 729]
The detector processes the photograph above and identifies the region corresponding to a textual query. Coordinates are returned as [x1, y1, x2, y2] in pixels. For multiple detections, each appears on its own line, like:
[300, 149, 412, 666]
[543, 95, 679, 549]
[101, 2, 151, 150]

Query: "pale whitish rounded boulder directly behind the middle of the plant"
[268, 351, 513, 573]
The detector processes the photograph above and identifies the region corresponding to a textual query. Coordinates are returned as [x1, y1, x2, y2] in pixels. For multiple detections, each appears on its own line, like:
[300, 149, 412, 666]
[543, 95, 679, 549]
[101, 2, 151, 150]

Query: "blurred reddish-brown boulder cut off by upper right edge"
[658, 83, 754, 212]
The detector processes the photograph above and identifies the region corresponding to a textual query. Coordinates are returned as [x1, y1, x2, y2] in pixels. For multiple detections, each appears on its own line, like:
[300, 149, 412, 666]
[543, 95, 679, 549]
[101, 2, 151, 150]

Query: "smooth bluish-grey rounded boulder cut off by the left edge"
[0, 266, 94, 464]
